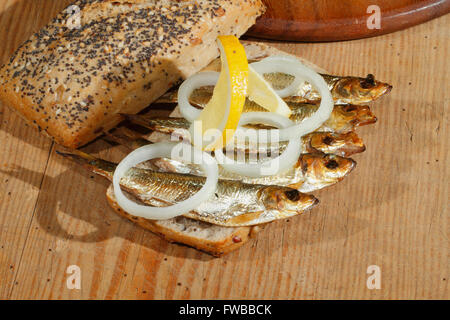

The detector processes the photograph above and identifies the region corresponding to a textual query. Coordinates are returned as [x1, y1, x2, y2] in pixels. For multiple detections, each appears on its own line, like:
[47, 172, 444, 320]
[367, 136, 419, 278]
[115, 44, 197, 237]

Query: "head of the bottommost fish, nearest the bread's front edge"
[259, 186, 319, 213]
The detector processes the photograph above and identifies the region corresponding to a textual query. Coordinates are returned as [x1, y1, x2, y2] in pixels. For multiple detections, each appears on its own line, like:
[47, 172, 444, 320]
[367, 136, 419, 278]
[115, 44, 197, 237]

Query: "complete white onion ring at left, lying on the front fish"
[113, 142, 219, 220]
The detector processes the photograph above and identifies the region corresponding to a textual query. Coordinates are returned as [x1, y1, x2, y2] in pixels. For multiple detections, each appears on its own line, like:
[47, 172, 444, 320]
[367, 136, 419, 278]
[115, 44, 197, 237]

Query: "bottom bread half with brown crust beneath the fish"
[106, 185, 264, 257]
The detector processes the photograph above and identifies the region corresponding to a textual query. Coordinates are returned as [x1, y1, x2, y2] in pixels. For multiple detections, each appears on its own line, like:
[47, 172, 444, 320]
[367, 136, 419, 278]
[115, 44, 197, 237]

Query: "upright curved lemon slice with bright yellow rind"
[189, 36, 249, 151]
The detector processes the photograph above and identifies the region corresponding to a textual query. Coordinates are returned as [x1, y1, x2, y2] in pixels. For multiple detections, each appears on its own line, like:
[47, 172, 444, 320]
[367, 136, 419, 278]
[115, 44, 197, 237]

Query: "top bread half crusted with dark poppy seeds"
[0, 0, 264, 148]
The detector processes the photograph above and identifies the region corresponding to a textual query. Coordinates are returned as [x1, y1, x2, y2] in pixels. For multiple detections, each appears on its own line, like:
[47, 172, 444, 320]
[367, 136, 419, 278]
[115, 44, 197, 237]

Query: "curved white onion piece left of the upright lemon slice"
[178, 71, 220, 122]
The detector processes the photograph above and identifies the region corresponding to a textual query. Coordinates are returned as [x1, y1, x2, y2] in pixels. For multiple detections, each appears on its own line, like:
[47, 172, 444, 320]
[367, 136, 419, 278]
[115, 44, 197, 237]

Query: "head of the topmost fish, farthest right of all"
[334, 74, 392, 103]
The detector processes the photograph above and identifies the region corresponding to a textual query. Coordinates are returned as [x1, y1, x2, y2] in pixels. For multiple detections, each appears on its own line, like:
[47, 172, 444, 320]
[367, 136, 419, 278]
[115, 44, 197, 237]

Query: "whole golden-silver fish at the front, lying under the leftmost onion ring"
[59, 150, 318, 227]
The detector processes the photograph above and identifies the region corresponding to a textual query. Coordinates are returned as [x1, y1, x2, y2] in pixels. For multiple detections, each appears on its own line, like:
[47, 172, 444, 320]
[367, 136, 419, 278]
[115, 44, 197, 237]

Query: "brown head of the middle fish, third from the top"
[309, 132, 366, 157]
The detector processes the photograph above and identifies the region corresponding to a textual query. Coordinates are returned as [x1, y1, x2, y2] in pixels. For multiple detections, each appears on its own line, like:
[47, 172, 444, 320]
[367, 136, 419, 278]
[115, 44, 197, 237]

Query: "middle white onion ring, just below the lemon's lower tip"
[214, 112, 301, 178]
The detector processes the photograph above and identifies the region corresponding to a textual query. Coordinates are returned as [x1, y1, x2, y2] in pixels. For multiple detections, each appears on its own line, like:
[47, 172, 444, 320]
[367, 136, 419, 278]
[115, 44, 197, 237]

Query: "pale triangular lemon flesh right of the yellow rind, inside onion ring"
[248, 66, 292, 118]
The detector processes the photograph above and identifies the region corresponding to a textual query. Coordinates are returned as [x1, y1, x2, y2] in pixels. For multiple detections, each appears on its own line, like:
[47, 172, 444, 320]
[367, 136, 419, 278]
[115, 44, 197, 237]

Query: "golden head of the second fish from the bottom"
[300, 154, 356, 183]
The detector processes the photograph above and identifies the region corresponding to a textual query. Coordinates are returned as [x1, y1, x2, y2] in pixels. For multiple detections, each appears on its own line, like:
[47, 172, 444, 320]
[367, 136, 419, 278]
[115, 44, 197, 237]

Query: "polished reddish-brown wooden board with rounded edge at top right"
[248, 0, 450, 41]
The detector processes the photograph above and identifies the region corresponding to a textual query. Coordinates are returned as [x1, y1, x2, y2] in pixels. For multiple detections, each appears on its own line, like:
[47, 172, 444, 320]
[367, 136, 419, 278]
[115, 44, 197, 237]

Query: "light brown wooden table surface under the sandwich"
[0, 0, 450, 299]
